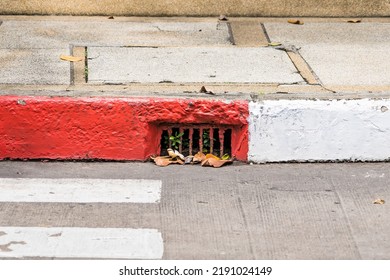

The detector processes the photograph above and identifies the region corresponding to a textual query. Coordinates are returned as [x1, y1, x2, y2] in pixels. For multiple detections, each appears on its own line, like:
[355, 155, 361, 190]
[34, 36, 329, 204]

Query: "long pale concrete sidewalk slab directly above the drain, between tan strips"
[88, 47, 303, 84]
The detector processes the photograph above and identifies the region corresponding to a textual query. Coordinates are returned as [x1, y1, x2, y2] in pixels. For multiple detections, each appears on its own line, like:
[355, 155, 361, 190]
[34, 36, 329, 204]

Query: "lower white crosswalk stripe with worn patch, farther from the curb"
[0, 227, 164, 259]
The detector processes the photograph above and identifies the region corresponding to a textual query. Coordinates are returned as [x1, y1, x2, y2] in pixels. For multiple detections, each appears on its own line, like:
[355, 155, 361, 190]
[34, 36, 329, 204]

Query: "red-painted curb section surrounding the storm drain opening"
[0, 96, 249, 161]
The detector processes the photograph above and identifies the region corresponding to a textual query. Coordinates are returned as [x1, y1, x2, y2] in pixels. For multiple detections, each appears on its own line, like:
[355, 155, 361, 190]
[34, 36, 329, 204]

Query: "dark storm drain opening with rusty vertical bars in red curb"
[160, 124, 232, 157]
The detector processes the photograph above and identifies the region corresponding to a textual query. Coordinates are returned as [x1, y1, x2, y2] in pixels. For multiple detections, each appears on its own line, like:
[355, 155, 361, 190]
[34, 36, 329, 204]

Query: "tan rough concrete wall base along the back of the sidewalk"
[0, 0, 390, 17]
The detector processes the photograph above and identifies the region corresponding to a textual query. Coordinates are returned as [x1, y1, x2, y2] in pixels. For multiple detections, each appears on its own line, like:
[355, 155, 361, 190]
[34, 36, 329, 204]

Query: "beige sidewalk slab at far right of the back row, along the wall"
[264, 22, 390, 47]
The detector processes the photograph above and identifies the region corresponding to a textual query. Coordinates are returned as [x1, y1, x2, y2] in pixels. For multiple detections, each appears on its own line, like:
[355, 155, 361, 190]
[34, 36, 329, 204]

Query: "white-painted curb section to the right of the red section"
[248, 99, 390, 163]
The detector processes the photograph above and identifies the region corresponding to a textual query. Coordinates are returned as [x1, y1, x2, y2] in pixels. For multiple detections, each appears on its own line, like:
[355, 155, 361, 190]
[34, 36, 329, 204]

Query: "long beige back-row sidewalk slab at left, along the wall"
[0, 18, 231, 49]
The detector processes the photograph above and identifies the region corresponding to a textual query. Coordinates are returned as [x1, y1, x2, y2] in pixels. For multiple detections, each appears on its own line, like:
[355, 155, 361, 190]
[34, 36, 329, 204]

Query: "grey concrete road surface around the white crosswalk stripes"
[0, 161, 390, 259]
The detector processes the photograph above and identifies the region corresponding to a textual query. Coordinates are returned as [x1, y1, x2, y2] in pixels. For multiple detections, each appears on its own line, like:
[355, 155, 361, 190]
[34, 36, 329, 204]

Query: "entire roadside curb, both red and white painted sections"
[0, 96, 390, 163]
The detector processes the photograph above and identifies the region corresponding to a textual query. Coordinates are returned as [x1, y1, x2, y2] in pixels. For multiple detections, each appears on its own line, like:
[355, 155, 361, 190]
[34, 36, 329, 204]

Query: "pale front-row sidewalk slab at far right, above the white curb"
[300, 44, 390, 86]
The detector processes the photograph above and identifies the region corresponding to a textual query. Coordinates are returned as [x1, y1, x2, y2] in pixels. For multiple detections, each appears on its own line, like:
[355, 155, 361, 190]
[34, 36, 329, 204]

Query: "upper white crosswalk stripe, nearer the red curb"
[0, 178, 162, 203]
